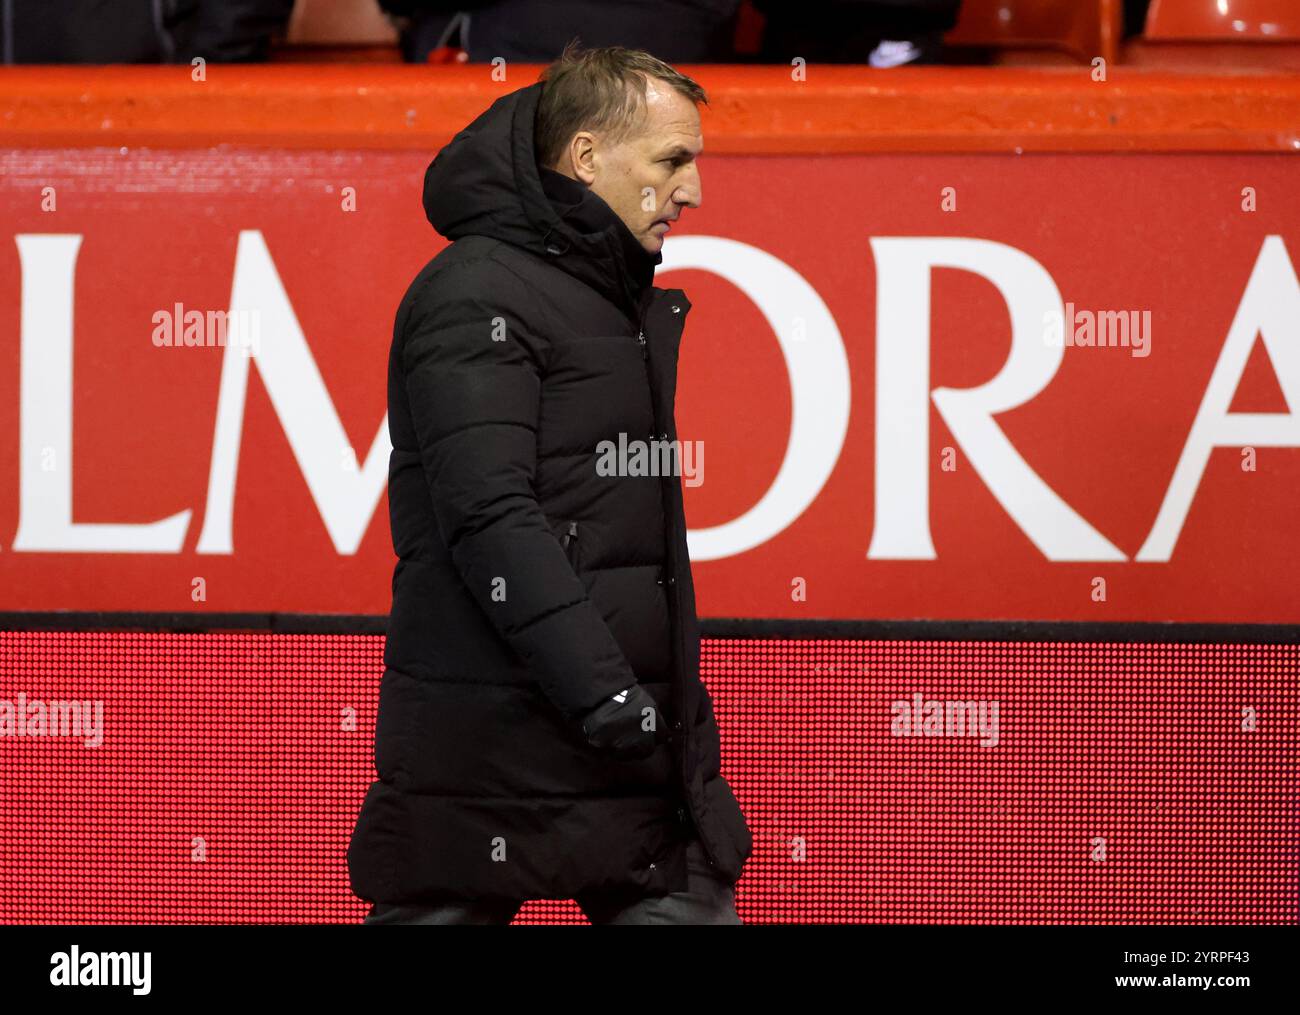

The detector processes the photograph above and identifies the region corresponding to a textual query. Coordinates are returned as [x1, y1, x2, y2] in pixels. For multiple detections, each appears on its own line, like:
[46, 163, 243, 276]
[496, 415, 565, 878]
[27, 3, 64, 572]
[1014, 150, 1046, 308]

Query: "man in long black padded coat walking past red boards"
[348, 45, 753, 924]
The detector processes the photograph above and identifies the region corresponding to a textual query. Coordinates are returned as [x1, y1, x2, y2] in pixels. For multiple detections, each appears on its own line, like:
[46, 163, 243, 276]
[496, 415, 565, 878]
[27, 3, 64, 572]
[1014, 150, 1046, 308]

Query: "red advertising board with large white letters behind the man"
[0, 143, 1300, 624]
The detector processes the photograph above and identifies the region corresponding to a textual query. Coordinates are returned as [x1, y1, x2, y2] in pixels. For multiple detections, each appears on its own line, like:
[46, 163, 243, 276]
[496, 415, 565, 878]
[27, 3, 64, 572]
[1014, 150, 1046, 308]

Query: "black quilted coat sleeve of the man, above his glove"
[402, 260, 636, 719]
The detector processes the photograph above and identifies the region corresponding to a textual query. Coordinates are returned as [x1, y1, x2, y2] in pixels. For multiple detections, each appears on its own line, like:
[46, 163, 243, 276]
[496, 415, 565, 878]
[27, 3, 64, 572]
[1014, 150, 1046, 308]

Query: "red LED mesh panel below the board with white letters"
[0, 632, 1300, 924]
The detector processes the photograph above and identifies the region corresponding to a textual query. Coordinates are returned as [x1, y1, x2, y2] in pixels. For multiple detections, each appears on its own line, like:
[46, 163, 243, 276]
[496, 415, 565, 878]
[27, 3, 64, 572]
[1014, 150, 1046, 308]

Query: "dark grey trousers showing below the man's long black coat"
[363, 840, 742, 925]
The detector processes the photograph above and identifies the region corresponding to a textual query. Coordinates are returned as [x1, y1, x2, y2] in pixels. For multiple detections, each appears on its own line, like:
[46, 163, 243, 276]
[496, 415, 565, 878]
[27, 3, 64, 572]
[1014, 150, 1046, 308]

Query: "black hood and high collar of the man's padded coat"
[424, 82, 663, 320]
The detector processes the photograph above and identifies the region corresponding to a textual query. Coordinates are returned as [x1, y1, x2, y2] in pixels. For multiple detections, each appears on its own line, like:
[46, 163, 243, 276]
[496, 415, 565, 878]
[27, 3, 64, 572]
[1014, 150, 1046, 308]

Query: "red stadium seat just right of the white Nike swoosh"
[944, 0, 1123, 62]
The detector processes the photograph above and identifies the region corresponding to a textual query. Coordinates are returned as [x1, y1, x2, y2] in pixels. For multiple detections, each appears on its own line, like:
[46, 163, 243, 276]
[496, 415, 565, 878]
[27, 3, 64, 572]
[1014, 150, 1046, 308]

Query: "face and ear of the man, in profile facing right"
[558, 78, 705, 253]
